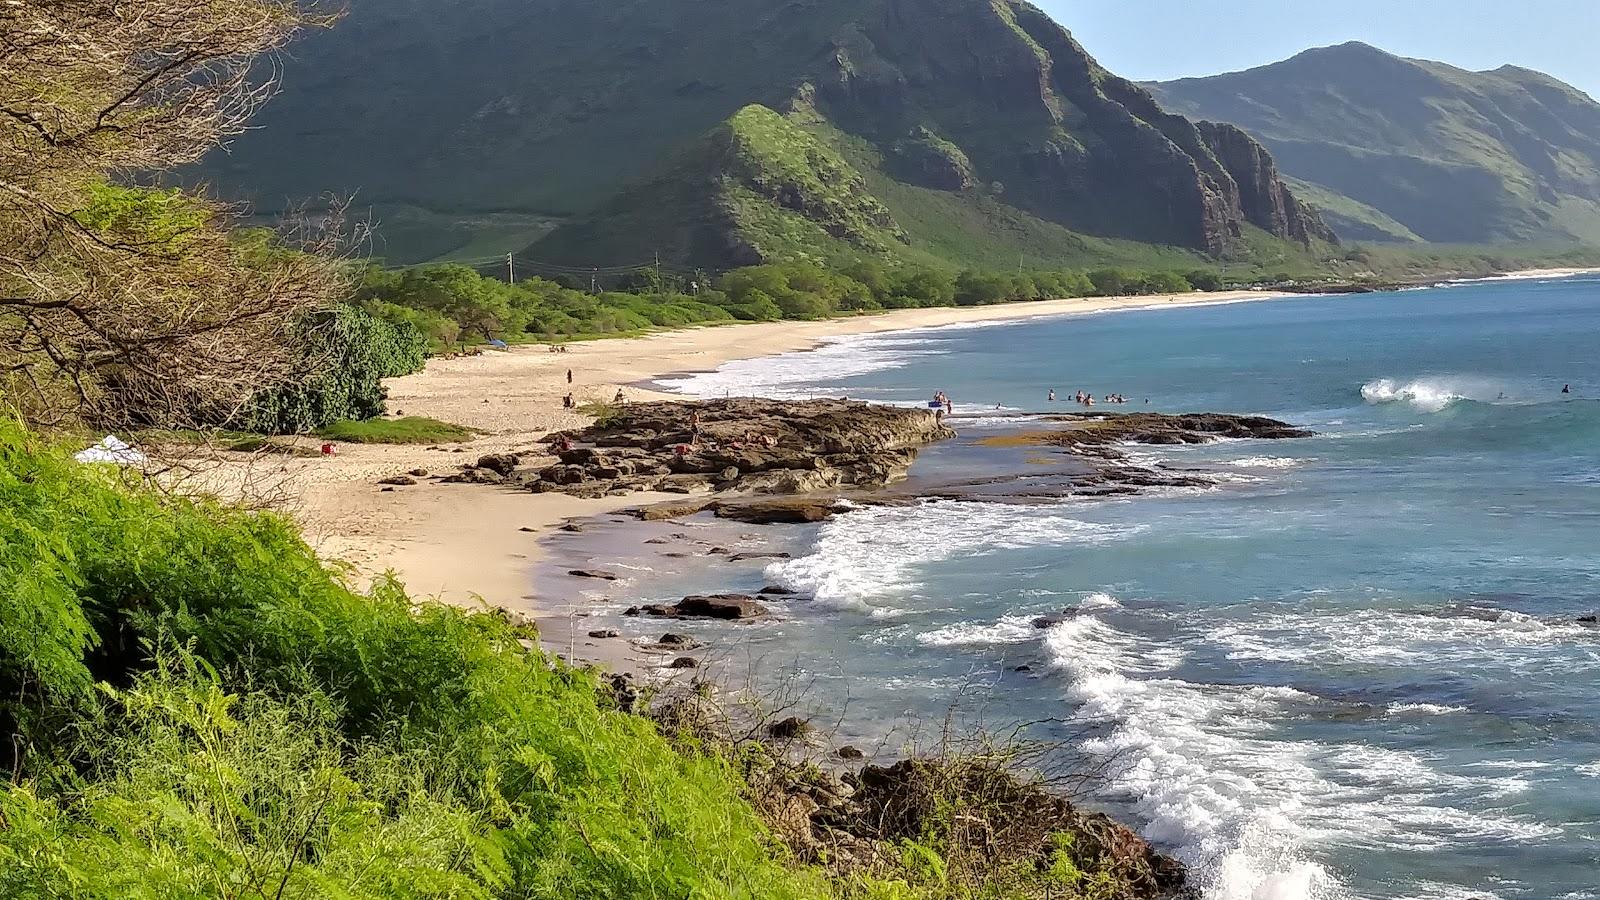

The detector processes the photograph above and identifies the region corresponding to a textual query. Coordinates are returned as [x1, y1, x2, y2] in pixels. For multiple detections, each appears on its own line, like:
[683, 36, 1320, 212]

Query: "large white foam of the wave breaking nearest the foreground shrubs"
[1046, 602, 1560, 900]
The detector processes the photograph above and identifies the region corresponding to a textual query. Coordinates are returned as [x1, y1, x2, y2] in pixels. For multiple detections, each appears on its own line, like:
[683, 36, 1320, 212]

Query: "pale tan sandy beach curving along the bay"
[265, 269, 1600, 634]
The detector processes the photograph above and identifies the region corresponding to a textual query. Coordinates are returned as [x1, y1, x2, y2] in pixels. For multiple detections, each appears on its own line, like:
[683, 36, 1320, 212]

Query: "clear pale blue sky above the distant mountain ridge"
[1034, 0, 1600, 98]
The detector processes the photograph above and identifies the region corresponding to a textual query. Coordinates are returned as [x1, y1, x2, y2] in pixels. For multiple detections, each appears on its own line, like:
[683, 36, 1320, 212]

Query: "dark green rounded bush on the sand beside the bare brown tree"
[238, 306, 427, 434]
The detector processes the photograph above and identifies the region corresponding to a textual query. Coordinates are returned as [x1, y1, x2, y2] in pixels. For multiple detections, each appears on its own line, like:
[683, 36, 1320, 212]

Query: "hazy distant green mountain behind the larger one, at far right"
[1146, 43, 1600, 243]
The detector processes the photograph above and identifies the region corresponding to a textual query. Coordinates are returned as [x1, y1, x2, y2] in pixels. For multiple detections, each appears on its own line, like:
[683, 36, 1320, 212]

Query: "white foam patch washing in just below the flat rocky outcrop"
[766, 501, 1139, 615]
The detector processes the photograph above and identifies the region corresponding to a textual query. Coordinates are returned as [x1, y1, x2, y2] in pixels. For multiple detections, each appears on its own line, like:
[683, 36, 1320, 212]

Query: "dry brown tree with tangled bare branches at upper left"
[0, 0, 347, 428]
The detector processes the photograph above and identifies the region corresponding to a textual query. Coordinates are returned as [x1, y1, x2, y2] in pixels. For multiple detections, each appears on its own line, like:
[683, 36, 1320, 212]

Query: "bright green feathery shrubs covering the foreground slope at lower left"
[0, 423, 827, 900]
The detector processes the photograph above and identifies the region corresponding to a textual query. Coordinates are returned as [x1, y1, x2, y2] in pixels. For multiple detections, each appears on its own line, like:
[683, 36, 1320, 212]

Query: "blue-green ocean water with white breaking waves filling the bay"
[563, 277, 1600, 900]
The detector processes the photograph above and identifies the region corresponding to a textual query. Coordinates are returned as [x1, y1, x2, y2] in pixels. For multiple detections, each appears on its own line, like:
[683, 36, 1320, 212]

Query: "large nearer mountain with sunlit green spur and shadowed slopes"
[203, 0, 1331, 266]
